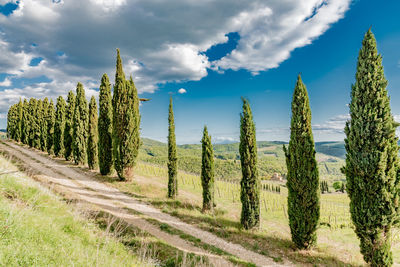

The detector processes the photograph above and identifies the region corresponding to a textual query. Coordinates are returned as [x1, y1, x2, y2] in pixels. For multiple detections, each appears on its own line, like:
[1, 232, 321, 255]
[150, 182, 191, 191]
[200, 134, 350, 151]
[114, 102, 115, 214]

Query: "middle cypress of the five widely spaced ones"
[239, 98, 260, 229]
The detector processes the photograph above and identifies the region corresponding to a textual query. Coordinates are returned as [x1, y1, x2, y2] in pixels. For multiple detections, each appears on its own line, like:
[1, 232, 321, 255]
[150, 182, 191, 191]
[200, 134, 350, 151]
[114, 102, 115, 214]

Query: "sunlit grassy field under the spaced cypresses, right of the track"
[91, 163, 400, 266]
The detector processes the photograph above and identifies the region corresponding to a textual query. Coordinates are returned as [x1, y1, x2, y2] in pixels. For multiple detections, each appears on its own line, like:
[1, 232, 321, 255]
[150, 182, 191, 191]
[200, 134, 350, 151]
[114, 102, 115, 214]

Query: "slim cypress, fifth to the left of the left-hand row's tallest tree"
[53, 96, 66, 156]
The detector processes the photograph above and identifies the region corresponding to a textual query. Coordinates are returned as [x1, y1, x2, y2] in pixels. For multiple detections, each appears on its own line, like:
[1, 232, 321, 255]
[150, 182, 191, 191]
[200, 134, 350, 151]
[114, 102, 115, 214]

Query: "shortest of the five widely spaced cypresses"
[201, 126, 214, 211]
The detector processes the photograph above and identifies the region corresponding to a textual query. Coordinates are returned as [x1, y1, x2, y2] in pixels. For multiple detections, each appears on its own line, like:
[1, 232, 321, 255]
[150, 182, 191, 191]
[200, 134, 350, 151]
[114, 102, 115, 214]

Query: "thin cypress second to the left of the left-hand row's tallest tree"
[87, 96, 98, 170]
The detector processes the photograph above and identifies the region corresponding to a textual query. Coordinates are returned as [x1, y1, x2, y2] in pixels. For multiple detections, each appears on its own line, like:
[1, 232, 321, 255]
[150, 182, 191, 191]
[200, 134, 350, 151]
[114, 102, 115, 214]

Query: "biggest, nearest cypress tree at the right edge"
[343, 29, 400, 266]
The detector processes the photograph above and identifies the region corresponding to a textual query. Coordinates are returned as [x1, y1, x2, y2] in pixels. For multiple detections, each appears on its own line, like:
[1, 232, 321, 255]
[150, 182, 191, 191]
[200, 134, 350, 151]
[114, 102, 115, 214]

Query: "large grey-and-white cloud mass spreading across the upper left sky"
[0, 0, 351, 117]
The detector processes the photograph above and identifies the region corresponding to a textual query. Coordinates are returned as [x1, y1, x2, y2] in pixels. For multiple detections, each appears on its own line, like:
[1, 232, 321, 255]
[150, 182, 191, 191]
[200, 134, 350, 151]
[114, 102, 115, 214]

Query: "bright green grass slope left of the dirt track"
[0, 157, 149, 266]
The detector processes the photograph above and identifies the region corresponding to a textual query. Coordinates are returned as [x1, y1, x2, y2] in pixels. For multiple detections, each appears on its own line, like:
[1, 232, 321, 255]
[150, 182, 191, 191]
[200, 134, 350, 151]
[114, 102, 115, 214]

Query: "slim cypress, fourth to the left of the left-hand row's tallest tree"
[64, 90, 76, 160]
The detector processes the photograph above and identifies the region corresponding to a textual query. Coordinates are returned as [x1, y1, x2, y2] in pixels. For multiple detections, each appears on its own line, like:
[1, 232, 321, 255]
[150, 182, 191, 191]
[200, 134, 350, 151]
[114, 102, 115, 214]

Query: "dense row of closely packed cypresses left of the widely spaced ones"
[7, 50, 140, 180]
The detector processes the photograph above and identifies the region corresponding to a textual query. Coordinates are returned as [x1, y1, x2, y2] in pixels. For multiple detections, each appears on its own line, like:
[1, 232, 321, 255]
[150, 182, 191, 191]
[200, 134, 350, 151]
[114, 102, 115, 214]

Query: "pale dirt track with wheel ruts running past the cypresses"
[0, 142, 290, 266]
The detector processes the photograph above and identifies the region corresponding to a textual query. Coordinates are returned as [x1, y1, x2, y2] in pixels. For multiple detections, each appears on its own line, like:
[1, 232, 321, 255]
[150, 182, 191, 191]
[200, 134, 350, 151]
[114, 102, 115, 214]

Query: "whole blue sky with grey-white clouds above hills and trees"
[0, 0, 400, 143]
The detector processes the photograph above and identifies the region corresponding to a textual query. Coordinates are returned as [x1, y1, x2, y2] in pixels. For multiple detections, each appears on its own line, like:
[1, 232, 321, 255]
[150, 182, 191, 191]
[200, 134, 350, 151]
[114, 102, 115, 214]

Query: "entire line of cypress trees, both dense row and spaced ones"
[7, 30, 400, 266]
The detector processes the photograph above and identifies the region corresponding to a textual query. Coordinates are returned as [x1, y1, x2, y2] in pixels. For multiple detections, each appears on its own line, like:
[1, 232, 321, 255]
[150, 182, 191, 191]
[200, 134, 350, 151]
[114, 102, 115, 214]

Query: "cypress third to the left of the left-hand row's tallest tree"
[72, 83, 89, 165]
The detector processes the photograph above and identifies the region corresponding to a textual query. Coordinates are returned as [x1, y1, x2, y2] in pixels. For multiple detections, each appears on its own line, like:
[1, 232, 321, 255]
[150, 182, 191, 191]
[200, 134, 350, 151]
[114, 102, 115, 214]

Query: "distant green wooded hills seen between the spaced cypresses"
[139, 138, 344, 180]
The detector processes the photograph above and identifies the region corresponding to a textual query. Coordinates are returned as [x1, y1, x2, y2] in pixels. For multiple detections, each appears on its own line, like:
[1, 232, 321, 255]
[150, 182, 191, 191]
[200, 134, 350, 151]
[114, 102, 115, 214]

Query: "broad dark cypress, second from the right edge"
[283, 75, 320, 249]
